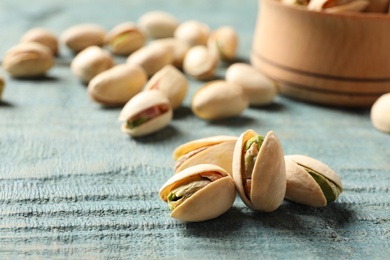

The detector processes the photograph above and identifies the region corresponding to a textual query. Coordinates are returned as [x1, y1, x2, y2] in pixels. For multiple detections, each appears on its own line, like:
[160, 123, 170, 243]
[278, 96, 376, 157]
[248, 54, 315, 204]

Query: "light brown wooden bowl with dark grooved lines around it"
[251, 0, 390, 106]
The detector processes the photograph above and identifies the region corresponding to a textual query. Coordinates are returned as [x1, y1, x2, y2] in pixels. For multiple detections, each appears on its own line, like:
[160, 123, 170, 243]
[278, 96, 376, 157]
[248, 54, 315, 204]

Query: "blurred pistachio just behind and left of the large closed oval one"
[70, 46, 115, 83]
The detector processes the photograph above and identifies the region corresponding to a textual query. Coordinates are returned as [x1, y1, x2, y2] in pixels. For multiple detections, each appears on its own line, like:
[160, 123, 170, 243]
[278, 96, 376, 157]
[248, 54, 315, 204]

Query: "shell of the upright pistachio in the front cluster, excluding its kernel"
[233, 129, 286, 212]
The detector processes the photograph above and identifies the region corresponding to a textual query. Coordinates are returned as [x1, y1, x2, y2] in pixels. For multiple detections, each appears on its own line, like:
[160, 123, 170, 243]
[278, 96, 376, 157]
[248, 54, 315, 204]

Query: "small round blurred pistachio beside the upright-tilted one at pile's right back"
[183, 45, 219, 80]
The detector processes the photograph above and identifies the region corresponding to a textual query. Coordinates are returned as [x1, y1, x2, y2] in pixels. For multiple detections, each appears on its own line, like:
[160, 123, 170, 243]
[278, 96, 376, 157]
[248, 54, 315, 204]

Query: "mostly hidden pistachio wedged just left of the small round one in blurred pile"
[150, 38, 190, 69]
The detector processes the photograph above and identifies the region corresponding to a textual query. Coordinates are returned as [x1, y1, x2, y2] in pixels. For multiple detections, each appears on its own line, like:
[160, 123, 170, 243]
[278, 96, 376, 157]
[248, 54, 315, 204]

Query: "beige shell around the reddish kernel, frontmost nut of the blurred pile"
[119, 90, 173, 137]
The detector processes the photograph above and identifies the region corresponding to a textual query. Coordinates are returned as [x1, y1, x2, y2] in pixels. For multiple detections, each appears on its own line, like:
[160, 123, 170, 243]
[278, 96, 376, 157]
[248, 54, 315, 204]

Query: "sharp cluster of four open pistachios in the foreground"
[159, 129, 342, 222]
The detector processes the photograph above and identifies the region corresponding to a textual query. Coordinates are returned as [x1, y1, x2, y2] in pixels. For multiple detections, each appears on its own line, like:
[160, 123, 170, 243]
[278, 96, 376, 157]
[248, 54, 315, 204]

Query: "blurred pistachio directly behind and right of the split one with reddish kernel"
[145, 64, 188, 109]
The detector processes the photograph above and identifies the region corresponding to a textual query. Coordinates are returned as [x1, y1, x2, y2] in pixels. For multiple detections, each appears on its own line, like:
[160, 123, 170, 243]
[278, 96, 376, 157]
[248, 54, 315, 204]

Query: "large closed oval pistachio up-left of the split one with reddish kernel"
[88, 64, 147, 106]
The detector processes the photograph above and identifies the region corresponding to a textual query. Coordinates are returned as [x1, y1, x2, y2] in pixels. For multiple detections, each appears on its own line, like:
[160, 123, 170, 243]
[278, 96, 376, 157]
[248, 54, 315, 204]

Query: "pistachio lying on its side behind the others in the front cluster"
[173, 135, 237, 176]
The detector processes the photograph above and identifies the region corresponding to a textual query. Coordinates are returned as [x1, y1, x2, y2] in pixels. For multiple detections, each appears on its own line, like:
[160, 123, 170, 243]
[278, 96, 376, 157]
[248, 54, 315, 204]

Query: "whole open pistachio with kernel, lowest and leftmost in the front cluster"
[160, 164, 236, 222]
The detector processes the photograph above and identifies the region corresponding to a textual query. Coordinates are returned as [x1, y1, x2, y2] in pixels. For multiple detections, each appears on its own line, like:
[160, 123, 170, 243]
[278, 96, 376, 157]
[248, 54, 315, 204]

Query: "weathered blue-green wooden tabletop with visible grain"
[0, 0, 390, 259]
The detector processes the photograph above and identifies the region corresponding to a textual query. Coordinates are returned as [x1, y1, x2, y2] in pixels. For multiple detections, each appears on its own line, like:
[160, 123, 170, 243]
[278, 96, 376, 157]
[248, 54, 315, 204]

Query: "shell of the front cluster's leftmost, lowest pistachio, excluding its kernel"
[160, 164, 236, 222]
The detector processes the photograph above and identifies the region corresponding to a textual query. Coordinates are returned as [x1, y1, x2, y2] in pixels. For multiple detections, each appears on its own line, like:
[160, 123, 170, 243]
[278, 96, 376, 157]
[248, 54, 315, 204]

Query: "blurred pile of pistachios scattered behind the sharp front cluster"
[3, 11, 278, 137]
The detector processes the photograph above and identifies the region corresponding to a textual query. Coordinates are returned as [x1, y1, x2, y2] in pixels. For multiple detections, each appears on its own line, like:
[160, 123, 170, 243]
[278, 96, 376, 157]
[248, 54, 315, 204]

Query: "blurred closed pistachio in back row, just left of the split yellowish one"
[60, 24, 106, 53]
